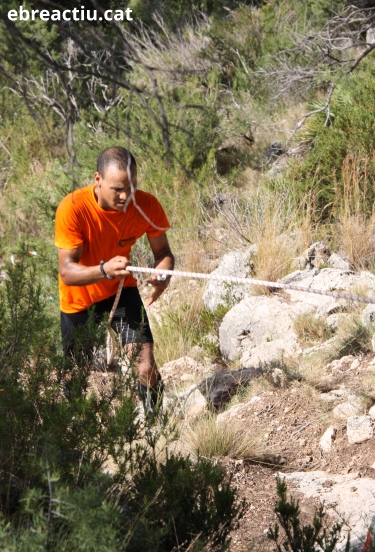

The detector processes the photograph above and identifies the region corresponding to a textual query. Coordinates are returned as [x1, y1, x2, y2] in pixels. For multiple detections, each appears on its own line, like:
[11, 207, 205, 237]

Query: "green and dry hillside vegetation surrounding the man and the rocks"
[0, 0, 375, 552]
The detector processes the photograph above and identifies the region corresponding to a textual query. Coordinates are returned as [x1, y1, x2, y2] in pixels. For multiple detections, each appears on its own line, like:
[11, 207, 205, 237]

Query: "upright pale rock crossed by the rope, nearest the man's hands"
[203, 246, 256, 311]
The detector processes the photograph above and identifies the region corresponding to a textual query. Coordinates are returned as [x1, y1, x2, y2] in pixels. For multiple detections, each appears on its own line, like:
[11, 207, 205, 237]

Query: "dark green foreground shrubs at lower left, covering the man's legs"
[0, 249, 242, 552]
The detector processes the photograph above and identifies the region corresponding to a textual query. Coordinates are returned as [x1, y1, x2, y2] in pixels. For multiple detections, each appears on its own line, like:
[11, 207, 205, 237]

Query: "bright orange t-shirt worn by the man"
[55, 186, 170, 313]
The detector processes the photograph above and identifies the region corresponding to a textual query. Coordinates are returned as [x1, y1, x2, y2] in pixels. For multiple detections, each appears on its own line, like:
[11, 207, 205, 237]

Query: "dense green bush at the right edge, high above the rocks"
[290, 65, 375, 217]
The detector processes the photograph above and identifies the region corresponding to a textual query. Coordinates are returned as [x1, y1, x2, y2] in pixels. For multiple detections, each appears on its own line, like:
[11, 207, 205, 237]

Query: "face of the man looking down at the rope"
[95, 165, 137, 211]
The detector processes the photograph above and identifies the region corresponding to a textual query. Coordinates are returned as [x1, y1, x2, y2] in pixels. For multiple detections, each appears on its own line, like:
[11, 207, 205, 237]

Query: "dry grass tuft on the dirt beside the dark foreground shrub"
[181, 414, 268, 459]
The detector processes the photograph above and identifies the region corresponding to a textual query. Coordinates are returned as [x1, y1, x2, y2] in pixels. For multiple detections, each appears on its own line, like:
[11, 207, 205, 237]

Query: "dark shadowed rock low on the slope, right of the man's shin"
[198, 368, 263, 408]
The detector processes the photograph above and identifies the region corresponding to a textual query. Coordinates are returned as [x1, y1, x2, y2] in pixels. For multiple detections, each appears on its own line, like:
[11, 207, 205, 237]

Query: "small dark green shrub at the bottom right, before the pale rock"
[267, 477, 350, 552]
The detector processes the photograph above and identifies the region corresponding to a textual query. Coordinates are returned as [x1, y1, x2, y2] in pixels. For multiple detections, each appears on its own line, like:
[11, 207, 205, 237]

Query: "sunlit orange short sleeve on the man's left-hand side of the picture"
[55, 194, 83, 249]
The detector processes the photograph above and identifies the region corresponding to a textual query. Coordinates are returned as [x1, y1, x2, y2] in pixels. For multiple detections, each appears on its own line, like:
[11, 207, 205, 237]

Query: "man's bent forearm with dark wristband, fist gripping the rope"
[58, 245, 130, 286]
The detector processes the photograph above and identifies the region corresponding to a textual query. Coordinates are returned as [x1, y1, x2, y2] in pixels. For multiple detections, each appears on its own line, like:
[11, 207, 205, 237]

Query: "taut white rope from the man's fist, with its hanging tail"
[107, 266, 375, 364]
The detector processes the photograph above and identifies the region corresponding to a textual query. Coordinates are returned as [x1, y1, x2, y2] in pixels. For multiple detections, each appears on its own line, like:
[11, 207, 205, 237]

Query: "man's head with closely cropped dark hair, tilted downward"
[95, 147, 137, 211]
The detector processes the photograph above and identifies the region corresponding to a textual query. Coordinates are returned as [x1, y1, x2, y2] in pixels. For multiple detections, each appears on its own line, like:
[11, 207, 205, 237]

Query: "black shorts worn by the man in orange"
[61, 287, 154, 354]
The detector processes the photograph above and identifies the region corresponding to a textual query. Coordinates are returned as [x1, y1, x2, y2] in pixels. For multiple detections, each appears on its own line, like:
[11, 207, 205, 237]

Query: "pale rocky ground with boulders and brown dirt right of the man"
[154, 244, 375, 552]
